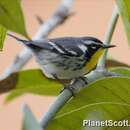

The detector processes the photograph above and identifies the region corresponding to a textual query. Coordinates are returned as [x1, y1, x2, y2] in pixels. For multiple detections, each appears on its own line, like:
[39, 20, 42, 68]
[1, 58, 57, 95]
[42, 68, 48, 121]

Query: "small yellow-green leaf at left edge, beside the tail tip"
[0, 25, 7, 51]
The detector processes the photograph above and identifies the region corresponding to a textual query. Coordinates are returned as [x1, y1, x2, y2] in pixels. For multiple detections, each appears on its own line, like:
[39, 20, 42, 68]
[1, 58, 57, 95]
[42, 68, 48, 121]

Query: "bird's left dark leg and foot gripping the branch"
[53, 74, 75, 96]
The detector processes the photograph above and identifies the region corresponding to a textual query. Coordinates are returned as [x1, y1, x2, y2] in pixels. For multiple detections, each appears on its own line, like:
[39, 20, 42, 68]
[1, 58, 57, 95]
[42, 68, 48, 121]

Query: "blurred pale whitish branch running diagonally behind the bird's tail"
[0, 0, 73, 80]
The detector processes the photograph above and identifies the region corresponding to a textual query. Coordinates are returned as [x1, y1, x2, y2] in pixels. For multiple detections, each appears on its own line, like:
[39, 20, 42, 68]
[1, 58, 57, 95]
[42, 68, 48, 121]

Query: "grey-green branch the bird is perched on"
[40, 70, 119, 130]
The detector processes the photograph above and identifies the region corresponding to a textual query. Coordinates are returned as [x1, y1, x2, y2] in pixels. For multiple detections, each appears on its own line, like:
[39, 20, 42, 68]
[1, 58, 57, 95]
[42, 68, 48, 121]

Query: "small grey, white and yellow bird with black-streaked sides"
[8, 34, 115, 80]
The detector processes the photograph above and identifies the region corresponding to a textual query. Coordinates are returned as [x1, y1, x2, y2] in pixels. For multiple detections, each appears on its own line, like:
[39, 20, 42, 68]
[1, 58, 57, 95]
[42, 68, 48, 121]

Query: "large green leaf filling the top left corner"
[0, 0, 28, 38]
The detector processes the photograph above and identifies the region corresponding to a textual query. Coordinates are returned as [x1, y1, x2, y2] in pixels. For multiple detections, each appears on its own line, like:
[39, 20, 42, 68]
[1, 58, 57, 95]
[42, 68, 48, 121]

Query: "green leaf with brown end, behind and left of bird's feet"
[4, 69, 62, 102]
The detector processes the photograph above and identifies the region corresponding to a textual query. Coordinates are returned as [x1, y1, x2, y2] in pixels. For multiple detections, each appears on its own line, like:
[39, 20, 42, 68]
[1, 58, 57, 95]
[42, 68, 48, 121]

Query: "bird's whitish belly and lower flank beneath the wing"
[37, 51, 83, 79]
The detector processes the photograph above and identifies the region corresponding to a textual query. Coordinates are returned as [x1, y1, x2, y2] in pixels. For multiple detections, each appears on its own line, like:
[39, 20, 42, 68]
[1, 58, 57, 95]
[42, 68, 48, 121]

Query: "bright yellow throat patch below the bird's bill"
[84, 48, 104, 73]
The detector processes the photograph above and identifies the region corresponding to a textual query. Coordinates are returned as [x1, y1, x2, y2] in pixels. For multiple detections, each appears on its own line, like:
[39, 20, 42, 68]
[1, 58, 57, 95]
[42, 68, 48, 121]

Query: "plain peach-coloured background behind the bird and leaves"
[0, 0, 130, 130]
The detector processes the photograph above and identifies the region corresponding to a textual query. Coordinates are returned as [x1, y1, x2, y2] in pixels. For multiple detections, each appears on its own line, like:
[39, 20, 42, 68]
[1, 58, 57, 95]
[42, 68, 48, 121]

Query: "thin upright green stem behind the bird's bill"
[97, 6, 119, 69]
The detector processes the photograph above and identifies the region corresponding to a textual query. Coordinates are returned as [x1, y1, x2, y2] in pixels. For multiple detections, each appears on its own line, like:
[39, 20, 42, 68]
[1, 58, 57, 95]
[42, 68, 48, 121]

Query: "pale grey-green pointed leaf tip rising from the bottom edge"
[22, 105, 43, 130]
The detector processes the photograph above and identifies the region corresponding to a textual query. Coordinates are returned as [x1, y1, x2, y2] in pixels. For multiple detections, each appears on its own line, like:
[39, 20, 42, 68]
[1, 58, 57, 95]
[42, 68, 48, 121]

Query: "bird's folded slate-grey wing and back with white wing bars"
[25, 37, 85, 57]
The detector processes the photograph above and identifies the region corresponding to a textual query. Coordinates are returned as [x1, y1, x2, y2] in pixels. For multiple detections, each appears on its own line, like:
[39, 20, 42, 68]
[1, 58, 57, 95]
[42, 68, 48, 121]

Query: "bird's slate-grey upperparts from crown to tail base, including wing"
[23, 37, 102, 57]
